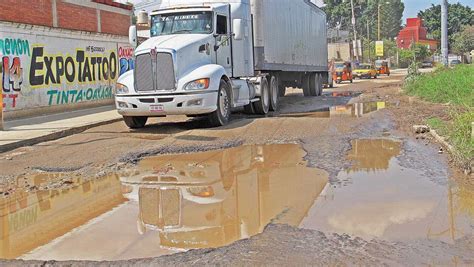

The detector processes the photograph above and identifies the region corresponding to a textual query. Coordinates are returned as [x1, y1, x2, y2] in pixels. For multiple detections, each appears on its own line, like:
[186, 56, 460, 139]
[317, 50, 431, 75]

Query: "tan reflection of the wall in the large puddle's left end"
[0, 173, 125, 259]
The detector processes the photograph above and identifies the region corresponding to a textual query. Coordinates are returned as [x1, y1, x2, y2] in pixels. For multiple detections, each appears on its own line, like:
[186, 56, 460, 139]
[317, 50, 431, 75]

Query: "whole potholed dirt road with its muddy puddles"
[0, 72, 474, 265]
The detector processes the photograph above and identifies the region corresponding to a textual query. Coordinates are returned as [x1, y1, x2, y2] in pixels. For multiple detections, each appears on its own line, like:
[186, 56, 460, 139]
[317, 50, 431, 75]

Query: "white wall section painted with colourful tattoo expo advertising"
[0, 23, 134, 119]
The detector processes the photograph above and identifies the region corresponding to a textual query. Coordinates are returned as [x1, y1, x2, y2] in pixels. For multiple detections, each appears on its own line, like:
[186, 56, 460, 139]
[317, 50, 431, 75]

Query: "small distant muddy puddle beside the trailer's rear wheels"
[280, 102, 388, 118]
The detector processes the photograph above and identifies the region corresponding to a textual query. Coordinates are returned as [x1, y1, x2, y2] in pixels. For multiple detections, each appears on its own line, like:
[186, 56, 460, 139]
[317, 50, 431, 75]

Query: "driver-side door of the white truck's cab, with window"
[216, 10, 232, 76]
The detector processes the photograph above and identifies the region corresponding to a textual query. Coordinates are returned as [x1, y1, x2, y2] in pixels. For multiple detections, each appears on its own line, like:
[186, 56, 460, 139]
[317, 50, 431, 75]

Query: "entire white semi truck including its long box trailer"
[115, 0, 328, 128]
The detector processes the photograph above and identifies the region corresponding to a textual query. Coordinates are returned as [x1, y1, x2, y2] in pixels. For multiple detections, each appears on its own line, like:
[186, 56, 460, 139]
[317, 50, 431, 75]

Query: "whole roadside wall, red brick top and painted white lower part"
[0, 0, 134, 119]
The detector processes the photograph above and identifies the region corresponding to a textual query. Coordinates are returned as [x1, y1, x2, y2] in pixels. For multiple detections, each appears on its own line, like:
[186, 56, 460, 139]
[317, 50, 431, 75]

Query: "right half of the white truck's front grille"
[156, 53, 175, 90]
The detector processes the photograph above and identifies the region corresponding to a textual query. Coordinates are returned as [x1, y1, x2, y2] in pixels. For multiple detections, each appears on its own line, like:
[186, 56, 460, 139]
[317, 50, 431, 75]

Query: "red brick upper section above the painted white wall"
[0, 0, 132, 36]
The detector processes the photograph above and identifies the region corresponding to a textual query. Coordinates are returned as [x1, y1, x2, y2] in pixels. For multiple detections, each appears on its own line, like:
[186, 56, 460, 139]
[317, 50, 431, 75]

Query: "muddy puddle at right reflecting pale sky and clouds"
[301, 139, 474, 243]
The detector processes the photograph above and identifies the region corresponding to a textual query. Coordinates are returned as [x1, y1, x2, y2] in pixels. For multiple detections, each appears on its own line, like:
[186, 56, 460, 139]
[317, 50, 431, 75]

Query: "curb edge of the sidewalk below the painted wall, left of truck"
[0, 118, 123, 153]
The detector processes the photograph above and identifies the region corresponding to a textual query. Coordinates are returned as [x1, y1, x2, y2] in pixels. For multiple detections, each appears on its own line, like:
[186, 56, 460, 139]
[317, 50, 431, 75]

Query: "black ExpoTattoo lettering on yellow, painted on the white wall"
[29, 47, 118, 86]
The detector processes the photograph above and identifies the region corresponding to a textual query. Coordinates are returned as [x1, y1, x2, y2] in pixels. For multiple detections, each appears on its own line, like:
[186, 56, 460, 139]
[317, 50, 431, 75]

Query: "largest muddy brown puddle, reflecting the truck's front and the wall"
[0, 144, 328, 260]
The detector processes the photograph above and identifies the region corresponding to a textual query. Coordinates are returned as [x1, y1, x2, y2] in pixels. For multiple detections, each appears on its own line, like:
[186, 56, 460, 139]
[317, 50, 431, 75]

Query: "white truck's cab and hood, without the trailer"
[116, 1, 255, 128]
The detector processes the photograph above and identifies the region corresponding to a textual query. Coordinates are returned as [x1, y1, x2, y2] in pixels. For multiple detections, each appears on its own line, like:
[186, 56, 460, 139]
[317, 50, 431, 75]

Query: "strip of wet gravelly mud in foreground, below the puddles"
[7, 225, 474, 266]
